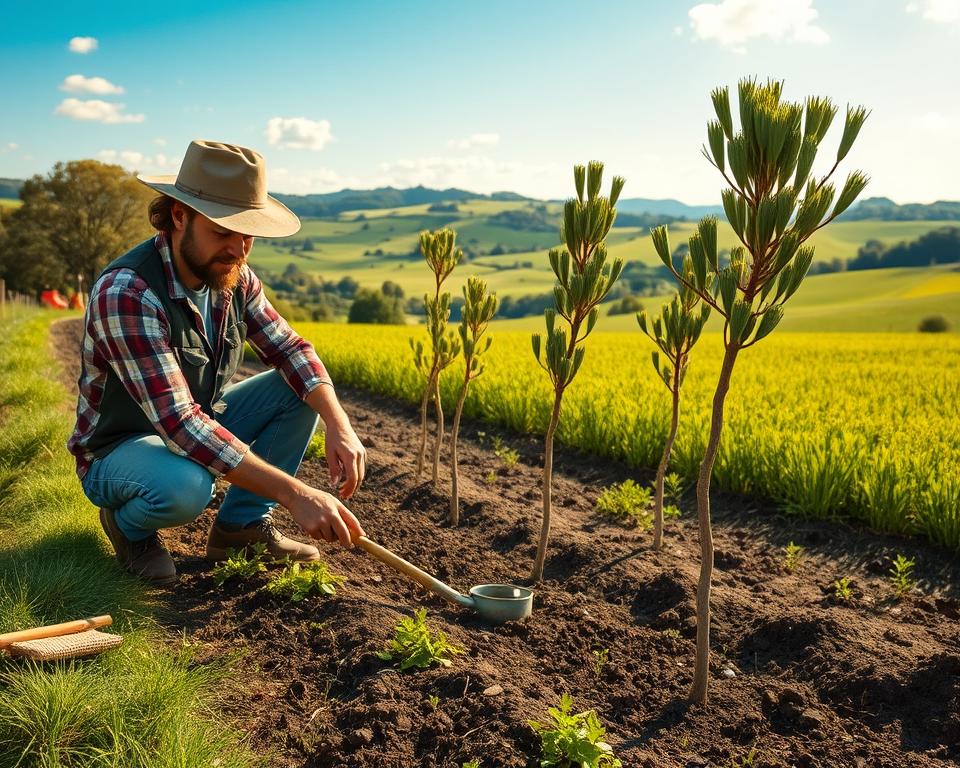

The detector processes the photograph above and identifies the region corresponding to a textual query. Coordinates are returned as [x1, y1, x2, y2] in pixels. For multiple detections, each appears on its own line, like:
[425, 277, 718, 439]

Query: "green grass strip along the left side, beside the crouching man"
[0, 311, 263, 768]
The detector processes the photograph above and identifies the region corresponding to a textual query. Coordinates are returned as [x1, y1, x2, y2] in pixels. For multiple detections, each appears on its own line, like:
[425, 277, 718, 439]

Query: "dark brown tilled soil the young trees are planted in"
[54, 322, 960, 768]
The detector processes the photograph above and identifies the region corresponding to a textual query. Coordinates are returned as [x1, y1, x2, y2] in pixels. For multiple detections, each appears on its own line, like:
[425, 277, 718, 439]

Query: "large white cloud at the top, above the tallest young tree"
[688, 0, 830, 53]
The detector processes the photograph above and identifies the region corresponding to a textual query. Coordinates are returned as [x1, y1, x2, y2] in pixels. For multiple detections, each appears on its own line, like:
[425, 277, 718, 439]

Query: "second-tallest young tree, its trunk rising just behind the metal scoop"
[530, 162, 624, 582]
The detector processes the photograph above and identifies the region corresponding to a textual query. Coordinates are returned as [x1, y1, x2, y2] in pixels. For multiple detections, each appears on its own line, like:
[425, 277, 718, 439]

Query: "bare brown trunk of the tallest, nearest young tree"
[690, 346, 740, 704]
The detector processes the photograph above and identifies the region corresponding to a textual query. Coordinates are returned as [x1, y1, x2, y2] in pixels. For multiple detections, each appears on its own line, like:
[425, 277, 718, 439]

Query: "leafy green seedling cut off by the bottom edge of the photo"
[530, 694, 623, 768]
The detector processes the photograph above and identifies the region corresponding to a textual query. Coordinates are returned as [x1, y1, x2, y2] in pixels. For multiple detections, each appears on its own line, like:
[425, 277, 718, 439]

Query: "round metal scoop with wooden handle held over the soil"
[355, 536, 533, 624]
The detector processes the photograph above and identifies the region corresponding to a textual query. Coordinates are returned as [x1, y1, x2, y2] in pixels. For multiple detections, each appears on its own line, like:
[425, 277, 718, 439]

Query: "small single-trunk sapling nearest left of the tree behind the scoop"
[450, 276, 497, 526]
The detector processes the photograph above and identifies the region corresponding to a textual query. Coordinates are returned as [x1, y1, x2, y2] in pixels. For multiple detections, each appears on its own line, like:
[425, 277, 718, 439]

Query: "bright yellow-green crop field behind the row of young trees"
[298, 323, 960, 548]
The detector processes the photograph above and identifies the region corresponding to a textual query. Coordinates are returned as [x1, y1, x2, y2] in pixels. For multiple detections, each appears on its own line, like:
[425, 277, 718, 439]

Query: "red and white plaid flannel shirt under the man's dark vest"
[67, 233, 333, 479]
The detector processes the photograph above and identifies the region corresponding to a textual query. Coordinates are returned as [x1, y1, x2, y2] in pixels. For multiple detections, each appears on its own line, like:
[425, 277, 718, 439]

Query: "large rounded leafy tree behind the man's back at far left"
[0, 160, 154, 291]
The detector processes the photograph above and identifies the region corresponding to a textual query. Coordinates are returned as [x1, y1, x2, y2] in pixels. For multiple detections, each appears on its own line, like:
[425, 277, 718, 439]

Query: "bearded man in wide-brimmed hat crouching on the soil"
[67, 141, 366, 585]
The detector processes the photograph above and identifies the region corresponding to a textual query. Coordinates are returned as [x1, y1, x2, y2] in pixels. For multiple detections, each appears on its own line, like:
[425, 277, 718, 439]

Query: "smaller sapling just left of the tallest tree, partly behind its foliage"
[637, 276, 710, 552]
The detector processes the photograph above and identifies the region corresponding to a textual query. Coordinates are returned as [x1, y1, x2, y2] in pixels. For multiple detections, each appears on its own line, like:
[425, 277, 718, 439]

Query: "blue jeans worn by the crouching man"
[82, 371, 317, 541]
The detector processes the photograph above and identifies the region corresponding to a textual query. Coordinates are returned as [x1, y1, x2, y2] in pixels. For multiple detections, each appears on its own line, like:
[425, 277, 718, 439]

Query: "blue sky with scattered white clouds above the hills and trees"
[0, 0, 960, 203]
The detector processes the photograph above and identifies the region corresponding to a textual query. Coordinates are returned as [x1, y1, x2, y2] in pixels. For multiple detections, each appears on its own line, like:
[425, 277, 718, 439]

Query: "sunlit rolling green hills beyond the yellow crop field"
[251, 200, 960, 330]
